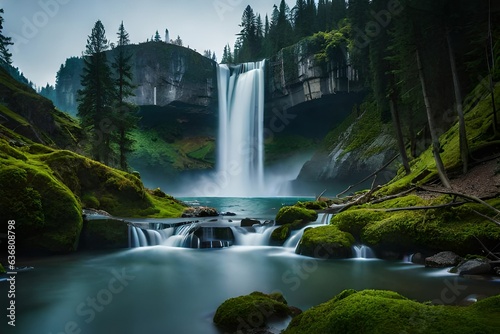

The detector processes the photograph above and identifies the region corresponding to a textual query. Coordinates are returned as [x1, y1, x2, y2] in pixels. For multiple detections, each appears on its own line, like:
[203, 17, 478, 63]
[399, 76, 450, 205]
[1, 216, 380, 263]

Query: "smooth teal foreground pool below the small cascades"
[0, 246, 500, 334]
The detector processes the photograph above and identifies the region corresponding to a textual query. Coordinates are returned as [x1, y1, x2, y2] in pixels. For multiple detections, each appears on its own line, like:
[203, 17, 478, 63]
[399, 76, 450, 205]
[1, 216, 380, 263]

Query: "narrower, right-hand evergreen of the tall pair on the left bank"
[112, 21, 138, 170]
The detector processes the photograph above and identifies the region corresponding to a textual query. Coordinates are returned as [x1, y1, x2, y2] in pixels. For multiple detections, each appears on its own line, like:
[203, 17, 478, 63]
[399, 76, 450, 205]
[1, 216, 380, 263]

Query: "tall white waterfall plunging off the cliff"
[216, 61, 265, 197]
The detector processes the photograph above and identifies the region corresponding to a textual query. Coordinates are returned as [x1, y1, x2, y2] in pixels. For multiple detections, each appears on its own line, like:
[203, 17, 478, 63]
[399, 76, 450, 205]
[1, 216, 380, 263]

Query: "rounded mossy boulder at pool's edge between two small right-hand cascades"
[295, 226, 355, 259]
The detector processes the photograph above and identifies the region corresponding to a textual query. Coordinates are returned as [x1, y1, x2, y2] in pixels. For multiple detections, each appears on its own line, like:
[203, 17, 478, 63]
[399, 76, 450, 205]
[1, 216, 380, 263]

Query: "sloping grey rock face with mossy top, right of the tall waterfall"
[295, 104, 398, 195]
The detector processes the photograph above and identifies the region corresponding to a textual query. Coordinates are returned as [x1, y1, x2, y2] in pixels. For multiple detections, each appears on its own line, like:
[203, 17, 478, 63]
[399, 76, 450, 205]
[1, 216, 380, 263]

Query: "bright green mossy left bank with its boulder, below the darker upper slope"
[0, 139, 184, 253]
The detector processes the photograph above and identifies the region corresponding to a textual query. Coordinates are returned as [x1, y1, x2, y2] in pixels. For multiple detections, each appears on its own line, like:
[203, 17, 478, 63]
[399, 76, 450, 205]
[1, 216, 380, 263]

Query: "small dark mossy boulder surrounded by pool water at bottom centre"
[213, 291, 295, 333]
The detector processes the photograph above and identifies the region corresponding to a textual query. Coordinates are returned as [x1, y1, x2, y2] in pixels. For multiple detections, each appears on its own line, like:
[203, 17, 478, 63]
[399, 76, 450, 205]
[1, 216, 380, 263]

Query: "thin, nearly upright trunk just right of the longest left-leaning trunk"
[446, 31, 469, 174]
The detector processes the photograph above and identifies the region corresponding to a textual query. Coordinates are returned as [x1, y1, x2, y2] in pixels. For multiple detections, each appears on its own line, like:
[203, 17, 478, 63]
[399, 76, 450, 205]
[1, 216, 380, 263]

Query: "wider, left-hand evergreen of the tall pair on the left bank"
[77, 21, 116, 164]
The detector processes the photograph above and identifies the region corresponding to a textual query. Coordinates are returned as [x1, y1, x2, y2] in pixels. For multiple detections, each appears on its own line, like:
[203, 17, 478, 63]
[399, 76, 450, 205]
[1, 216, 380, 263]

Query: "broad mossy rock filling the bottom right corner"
[284, 290, 500, 334]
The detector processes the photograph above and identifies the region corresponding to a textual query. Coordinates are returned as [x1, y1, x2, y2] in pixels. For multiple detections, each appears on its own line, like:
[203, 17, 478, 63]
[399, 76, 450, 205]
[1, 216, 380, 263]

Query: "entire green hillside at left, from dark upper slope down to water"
[0, 69, 184, 253]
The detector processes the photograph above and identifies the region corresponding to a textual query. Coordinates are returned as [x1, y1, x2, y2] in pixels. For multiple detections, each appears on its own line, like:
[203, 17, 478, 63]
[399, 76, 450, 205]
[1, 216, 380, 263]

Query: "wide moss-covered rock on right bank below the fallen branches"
[331, 195, 500, 256]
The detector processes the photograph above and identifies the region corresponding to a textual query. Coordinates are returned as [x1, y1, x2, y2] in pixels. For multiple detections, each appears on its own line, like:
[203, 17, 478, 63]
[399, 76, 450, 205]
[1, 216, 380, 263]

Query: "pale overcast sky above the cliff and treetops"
[0, 0, 295, 86]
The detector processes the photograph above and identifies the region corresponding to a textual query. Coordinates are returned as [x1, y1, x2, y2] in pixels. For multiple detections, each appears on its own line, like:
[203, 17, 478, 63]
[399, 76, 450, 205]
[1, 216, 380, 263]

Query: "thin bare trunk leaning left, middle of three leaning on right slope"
[416, 48, 451, 188]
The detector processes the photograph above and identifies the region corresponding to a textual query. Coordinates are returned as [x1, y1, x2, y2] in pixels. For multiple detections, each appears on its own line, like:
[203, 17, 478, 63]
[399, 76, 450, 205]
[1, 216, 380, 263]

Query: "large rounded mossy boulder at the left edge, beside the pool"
[0, 150, 82, 253]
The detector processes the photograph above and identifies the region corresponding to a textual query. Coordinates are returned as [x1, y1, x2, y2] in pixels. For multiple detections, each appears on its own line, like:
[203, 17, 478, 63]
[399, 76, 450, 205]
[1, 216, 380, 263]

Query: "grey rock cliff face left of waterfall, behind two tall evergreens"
[55, 42, 217, 115]
